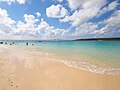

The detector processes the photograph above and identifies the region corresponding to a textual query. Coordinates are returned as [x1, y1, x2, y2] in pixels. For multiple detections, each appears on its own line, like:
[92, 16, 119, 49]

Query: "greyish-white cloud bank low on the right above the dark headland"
[71, 10, 120, 37]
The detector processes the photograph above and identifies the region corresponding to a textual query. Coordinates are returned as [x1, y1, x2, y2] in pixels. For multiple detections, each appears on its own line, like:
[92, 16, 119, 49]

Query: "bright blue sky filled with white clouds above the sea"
[0, 0, 120, 40]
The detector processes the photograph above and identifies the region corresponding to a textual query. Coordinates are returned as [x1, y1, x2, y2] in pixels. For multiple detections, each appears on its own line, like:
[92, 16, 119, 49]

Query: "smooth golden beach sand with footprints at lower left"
[0, 45, 120, 90]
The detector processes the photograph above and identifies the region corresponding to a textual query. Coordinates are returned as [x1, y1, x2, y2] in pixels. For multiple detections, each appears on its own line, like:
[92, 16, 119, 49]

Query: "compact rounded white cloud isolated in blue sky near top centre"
[46, 4, 68, 18]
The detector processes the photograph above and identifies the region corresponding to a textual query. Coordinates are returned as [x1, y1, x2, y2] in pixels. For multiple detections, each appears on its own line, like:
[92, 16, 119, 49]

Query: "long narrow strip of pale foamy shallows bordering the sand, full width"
[2, 45, 120, 76]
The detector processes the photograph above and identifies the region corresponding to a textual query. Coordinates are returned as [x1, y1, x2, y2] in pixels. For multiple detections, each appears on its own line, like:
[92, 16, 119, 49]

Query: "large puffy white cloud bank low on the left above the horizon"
[0, 8, 66, 39]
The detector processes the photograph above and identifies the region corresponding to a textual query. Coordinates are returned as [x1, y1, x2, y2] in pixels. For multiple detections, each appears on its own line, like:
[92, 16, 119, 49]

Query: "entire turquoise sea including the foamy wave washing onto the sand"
[0, 41, 120, 75]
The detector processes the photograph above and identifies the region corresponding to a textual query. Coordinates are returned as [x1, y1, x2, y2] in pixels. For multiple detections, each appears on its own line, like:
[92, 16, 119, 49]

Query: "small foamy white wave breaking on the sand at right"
[59, 60, 120, 76]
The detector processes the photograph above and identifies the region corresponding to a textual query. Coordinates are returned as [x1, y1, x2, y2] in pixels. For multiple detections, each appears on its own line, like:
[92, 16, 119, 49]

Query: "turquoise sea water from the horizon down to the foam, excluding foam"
[14, 41, 120, 67]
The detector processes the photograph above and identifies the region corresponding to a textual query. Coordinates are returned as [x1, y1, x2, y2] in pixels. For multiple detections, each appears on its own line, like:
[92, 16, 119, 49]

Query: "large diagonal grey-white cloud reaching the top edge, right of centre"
[60, 0, 106, 27]
